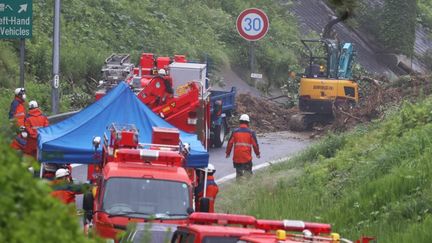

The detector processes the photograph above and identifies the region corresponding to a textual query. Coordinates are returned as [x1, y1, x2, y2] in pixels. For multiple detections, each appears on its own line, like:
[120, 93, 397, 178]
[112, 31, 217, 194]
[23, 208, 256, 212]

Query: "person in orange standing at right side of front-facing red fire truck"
[195, 164, 219, 213]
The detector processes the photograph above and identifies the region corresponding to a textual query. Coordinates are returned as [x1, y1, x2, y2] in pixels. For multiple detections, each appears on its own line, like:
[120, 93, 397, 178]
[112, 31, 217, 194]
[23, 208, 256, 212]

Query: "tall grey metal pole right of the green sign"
[51, 0, 60, 114]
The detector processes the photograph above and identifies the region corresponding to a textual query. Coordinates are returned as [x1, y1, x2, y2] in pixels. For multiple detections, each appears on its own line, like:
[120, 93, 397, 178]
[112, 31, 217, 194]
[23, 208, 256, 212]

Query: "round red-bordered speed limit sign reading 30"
[236, 8, 269, 41]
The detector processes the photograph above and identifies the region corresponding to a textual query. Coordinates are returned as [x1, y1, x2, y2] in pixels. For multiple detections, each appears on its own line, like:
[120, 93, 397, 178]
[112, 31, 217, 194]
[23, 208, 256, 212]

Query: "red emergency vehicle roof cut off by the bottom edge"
[171, 213, 374, 243]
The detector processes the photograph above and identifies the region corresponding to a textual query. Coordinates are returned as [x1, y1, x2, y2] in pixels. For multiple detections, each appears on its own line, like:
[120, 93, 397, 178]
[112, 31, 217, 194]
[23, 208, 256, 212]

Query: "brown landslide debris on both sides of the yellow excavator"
[229, 76, 432, 137]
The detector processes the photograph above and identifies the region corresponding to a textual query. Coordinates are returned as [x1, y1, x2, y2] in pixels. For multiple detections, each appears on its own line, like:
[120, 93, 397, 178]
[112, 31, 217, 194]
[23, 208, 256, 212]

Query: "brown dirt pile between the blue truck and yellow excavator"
[230, 94, 298, 133]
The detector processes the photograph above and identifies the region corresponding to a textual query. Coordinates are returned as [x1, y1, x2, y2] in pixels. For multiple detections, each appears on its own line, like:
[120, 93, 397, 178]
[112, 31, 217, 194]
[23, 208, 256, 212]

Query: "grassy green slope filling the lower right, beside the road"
[218, 98, 432, 243]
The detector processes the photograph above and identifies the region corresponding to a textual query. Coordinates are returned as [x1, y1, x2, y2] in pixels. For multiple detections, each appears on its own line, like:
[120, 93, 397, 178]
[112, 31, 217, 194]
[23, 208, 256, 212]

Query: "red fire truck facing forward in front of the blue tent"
[83, 124, 208, 239]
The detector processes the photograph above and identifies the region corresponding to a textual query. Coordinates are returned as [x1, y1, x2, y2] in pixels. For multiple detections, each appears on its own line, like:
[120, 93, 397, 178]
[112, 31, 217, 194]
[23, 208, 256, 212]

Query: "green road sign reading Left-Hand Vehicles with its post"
[0, 0, 33, 87]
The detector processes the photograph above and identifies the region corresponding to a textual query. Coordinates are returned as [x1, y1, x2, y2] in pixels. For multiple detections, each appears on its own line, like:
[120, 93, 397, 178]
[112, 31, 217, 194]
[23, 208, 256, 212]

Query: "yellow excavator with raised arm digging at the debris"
[290, 12, 359, 131]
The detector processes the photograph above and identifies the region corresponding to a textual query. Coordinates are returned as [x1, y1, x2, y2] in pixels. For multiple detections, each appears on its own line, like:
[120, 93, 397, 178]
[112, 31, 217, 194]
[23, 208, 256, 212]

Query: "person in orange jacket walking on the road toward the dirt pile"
[226, 114, 261, 179]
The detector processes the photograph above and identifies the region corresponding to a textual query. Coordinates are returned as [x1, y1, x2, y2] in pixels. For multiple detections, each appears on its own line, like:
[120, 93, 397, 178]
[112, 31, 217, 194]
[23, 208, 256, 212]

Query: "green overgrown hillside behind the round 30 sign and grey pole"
[0, 0, 300, 124]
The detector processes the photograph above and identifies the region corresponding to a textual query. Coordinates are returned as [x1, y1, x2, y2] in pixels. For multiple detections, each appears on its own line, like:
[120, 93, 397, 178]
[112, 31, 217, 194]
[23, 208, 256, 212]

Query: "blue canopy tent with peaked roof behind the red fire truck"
[38, 82, 209, 168]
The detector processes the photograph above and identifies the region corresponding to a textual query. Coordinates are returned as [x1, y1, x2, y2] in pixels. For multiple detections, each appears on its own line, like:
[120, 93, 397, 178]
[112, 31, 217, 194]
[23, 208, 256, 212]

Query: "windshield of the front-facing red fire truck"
[102, 178, 190, 218]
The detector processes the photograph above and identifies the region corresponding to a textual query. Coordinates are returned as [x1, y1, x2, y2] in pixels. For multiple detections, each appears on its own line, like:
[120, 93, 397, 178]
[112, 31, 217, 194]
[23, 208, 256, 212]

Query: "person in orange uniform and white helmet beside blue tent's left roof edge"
[24, 100, 49, 157]
